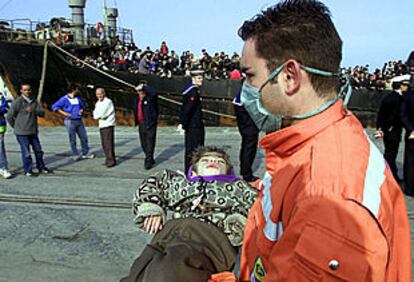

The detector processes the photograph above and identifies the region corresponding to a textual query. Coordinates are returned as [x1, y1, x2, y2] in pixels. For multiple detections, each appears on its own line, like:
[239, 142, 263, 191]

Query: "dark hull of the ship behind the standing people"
[0, 41, 384, 126]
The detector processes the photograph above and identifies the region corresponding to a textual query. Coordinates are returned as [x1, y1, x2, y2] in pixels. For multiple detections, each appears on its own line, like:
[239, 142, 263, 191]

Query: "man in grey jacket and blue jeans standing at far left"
[7, 83, 51, 176]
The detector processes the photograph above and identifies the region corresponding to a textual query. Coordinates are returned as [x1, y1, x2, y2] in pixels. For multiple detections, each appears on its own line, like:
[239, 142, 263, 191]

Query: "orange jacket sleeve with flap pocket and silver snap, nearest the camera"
[264, 197, 389, 282]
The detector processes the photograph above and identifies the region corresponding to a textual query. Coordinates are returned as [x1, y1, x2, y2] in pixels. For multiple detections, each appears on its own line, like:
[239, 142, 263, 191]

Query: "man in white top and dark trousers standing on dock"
[93, 88, 116, 168]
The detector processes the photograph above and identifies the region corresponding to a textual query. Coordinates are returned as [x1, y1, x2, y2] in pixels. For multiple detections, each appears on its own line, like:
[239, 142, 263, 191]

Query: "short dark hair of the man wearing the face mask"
[238, 0, 342, 97]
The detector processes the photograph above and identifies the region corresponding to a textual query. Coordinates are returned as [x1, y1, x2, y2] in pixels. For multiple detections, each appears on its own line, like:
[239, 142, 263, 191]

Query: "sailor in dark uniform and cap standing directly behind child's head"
[178, 70, 205, 172]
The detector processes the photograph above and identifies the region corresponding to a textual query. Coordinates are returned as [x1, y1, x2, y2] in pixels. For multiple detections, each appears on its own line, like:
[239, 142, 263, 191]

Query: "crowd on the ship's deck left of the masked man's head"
[75, 41, 241, 80]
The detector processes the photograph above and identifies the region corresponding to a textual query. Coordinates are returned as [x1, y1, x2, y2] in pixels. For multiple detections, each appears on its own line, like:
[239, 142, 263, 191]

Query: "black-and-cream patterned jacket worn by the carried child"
[133, 170, 258, 246]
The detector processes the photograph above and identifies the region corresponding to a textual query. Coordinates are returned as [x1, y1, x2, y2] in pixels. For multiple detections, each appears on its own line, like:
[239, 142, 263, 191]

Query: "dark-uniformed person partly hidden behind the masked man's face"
[233, 93, 259, 182]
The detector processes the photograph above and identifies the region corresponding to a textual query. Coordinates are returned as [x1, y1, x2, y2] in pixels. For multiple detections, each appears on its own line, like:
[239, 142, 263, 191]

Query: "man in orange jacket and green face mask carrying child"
[211, 0, 411, 281]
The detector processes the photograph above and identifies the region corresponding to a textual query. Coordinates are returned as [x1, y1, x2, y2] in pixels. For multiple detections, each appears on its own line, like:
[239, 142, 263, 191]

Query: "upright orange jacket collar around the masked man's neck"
[259, 100, 347, 156]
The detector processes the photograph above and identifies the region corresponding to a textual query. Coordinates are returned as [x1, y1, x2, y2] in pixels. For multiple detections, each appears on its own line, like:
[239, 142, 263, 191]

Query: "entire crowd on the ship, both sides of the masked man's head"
[69, 37, 409, 91]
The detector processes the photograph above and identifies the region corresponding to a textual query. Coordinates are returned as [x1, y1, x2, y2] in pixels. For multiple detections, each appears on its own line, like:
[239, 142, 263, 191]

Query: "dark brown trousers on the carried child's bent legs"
[122, 218, 236, 282]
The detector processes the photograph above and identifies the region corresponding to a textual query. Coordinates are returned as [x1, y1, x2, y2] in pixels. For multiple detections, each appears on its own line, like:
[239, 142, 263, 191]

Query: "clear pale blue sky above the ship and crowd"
[0, 0, 414, 71]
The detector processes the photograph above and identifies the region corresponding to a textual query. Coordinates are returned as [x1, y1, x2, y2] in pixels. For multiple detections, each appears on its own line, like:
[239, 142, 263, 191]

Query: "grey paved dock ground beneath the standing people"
[0, 127, 414, 281]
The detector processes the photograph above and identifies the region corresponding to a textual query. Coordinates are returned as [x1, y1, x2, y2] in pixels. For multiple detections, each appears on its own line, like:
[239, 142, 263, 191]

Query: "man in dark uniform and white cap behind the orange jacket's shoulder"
[375, 76, 404, 181]
